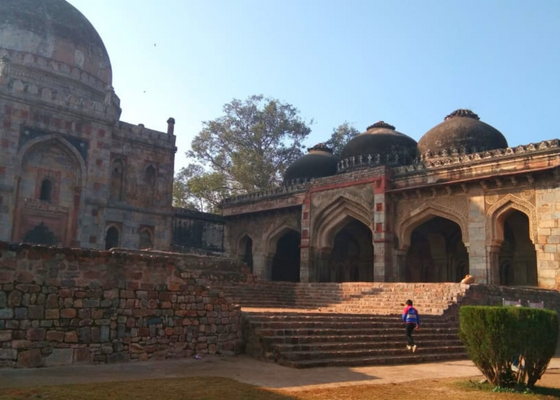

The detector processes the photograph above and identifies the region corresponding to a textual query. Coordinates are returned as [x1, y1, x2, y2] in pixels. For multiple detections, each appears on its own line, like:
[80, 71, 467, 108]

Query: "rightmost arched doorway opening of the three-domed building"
[499, 210, 537, 286]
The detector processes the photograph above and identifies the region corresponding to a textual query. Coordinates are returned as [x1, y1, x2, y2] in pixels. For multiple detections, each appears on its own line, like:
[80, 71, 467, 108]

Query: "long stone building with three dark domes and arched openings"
[223, 110, 560, 288]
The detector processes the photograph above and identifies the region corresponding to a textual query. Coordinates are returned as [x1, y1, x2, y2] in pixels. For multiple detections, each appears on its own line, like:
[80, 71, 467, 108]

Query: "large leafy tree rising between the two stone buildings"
[174, 95, 312, 211]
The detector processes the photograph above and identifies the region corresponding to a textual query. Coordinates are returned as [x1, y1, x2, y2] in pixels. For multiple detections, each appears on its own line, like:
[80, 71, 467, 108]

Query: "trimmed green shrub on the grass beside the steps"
[459, 306, 558, 388]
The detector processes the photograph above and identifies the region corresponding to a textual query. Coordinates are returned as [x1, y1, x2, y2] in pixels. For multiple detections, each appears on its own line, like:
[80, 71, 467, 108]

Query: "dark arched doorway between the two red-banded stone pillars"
[321, 218, 373, 282]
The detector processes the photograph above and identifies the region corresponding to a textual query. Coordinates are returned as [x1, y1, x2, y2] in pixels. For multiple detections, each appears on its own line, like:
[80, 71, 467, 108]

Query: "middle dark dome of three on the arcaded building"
[340, 121, 417, 166]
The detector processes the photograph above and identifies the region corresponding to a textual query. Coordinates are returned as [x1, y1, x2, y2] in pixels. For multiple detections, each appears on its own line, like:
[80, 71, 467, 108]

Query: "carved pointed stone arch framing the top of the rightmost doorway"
[486, 193, 537, 245]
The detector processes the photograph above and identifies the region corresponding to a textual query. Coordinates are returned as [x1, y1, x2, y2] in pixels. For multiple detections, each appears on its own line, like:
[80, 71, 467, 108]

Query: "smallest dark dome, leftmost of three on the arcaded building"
[284, 143, 338, 183]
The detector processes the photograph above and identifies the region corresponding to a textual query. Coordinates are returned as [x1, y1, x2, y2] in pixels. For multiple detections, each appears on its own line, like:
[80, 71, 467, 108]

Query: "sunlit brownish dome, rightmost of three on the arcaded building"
[418, 110, 508, 155]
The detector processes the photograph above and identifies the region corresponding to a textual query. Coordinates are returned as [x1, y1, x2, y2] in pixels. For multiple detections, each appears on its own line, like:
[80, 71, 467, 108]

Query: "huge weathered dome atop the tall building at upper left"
[0, 0, 112, 89]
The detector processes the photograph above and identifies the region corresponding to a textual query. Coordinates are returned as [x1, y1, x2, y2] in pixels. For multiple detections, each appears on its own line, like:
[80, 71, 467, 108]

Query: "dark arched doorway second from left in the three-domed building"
[271, 230, 301, 282]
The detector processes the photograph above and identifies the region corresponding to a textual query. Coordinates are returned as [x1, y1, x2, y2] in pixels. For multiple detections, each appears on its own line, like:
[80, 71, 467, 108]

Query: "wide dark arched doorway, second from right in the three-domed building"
[405, 217, 469, 282]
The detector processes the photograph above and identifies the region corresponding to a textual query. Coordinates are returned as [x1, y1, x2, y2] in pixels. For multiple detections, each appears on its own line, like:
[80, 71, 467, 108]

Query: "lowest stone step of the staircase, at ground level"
[277, 354, 467, 368]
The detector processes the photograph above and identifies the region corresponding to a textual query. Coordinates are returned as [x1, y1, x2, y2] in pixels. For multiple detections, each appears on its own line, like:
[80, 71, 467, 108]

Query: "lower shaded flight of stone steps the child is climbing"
[243, 310, 466, 368]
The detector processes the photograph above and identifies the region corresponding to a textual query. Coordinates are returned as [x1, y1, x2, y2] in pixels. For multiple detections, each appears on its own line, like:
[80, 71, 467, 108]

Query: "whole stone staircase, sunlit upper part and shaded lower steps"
[217, 281, 468, 368]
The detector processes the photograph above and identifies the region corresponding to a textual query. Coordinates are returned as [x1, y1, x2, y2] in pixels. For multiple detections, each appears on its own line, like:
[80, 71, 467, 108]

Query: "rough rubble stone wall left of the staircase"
[0, 242, 248, 367]
